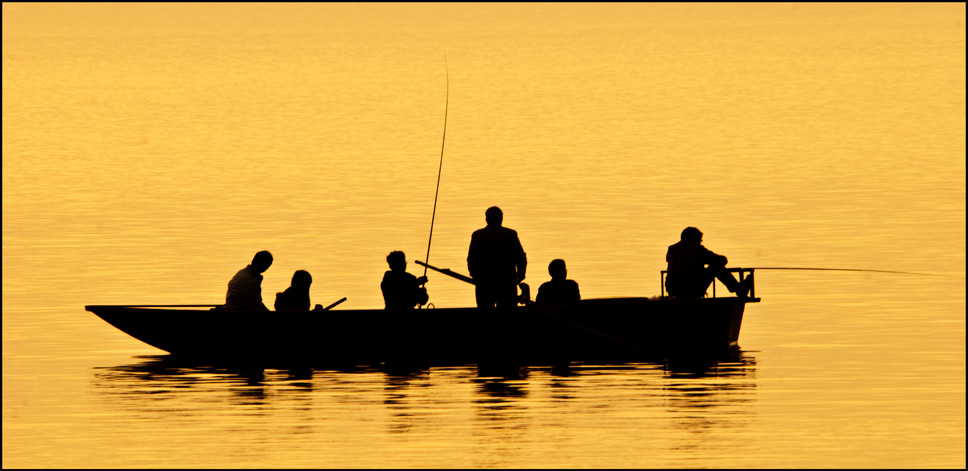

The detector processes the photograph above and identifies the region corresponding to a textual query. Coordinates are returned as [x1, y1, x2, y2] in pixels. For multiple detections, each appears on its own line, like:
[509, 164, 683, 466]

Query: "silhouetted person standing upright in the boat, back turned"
[467, 206, 528, 308]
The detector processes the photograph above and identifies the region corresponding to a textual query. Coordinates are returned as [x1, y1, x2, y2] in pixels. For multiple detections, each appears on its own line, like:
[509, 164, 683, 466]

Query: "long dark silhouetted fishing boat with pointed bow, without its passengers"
[85, 268, 760, 366]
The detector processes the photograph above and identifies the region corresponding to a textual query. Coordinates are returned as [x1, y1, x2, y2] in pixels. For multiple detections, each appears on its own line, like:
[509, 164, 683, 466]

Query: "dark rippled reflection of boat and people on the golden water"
[94, 348, 756, 440]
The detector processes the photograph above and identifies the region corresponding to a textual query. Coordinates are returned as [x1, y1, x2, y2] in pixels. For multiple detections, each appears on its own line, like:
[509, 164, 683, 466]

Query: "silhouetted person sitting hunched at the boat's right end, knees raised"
[666, 227, 752, 298]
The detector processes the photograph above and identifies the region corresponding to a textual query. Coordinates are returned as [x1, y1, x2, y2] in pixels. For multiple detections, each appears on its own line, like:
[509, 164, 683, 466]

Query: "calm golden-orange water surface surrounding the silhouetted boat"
[2, 3, 965, 468]
